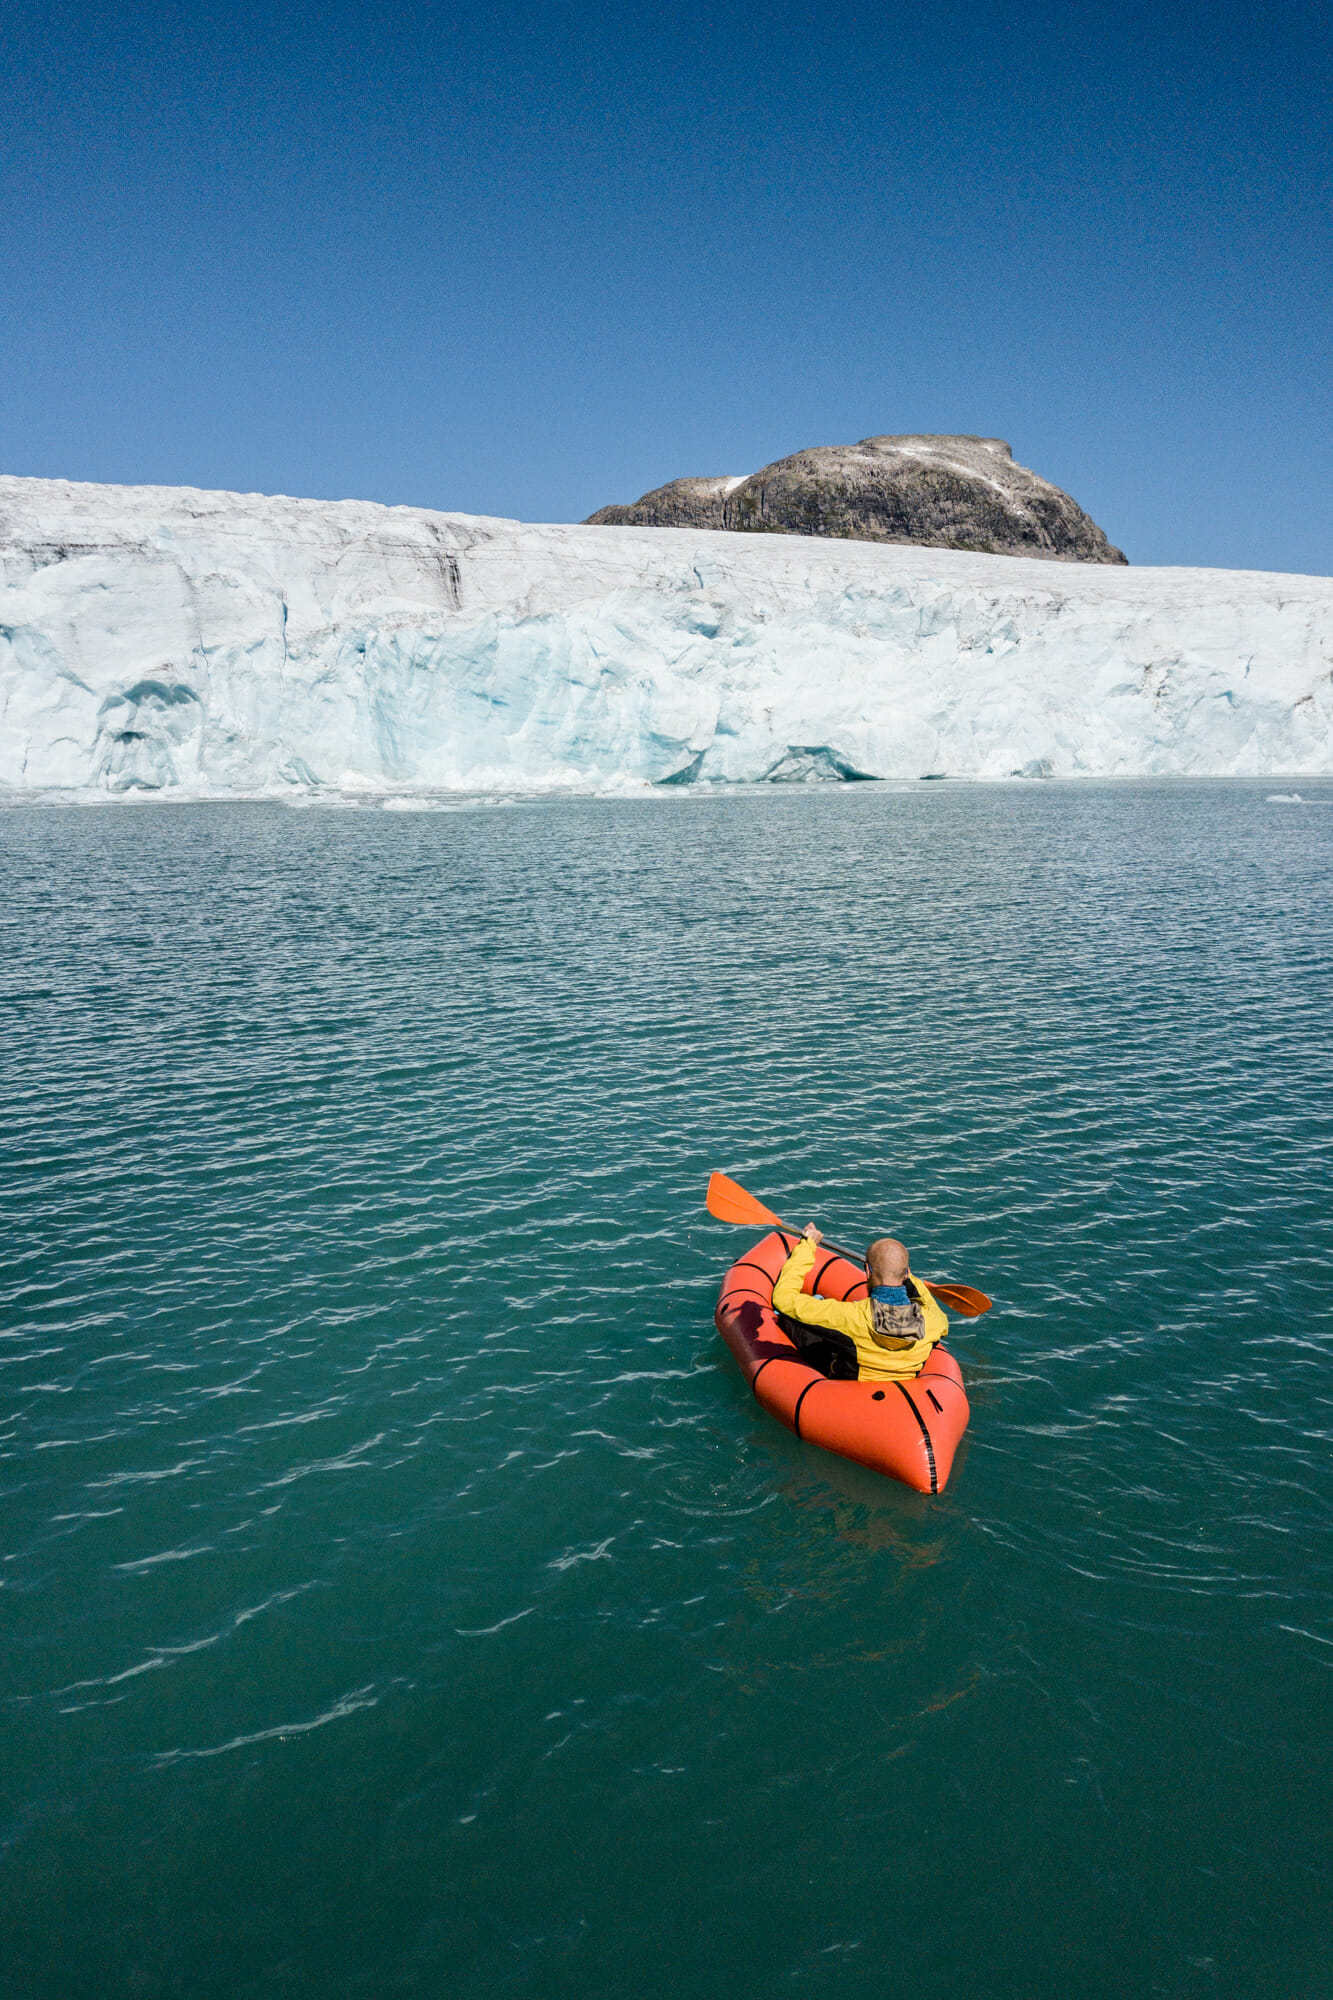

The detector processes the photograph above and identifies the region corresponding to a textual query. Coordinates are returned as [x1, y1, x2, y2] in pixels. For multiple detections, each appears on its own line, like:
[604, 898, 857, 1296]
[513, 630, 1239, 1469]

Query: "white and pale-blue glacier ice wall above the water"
[0, 478, 1333, 798]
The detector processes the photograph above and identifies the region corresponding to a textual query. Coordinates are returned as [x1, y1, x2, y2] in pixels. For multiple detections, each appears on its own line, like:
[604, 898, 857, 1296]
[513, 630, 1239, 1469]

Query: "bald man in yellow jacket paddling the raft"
[773, 1222, 949, 1382]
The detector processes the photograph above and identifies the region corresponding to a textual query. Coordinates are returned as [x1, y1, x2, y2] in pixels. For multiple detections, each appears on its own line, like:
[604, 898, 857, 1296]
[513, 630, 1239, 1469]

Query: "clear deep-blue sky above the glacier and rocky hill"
[0, 0, 1333, 574]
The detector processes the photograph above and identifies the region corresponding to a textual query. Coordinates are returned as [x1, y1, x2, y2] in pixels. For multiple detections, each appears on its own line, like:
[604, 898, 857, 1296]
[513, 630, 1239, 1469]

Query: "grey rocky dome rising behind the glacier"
[586, 438, 1125, 562]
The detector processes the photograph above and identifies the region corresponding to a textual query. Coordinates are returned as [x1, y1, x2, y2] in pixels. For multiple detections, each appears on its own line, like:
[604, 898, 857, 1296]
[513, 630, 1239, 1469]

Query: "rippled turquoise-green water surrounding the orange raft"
[0, 782, 1333, 2000]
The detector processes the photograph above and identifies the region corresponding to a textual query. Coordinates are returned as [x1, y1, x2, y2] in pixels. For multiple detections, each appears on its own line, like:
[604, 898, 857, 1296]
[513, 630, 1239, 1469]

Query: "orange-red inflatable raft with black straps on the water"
[713, 1230, 969, 1494]
